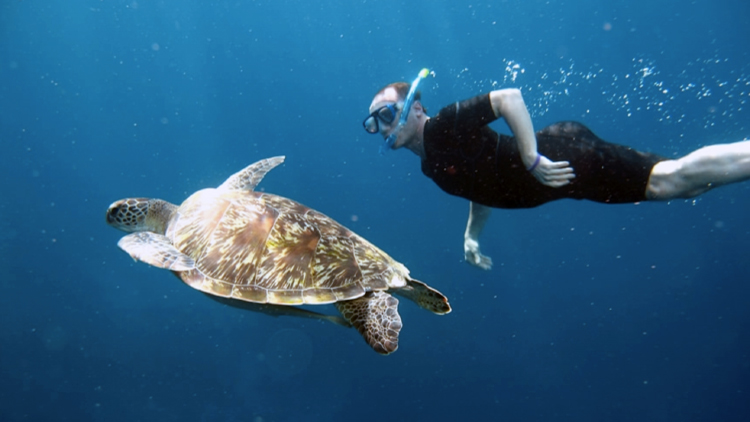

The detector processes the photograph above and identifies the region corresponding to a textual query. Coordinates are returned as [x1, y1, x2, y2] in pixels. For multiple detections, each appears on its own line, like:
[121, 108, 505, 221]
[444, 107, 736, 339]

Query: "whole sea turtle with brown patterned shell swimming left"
[107, 156, 451, 355]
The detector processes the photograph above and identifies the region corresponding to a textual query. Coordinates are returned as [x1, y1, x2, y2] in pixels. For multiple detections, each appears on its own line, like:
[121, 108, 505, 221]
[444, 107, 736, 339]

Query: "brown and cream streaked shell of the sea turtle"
[166, 189, 408, 305]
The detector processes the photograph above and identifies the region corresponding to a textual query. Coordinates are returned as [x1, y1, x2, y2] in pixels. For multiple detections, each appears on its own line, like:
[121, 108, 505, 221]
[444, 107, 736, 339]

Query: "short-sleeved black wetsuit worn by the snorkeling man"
[422, 95, 665, 208]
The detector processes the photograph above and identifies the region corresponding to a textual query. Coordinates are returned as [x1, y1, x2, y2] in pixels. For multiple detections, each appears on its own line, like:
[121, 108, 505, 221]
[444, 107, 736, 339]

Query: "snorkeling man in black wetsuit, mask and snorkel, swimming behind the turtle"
[364, 70, 750, 270]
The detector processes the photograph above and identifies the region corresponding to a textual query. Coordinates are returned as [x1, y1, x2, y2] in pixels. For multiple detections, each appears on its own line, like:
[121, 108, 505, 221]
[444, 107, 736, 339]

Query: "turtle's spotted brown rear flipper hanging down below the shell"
[336, 291, 401, 355]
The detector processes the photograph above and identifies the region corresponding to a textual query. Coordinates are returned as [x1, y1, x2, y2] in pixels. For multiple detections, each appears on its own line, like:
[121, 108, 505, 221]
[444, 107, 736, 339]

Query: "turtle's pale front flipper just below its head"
[117, 232, 195, 271]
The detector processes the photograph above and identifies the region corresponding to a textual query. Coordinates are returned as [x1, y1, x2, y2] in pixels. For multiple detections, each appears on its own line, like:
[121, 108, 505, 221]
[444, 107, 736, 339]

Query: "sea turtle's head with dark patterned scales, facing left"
[107, 198, 177, 234]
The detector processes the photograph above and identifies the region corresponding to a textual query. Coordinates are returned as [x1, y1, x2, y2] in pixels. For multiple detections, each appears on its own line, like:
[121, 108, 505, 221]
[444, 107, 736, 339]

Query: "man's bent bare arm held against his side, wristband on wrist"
[490, 88, 575, 187]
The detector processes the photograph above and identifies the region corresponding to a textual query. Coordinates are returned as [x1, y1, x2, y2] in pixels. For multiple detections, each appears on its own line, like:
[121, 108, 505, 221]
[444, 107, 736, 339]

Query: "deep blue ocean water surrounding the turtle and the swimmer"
[0, 0, 750, 422]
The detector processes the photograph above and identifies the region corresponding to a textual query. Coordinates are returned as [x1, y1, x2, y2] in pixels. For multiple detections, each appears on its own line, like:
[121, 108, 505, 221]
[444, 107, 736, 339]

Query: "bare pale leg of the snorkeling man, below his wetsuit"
[646, 140, 750, 200]
